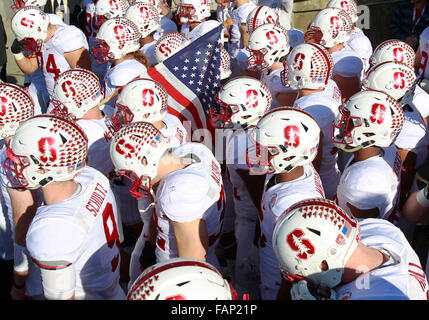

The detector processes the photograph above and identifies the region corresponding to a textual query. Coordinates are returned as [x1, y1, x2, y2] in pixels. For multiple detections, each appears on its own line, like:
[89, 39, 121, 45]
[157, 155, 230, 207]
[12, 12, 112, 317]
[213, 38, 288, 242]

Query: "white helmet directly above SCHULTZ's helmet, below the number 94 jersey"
[51, 68, 104, 119]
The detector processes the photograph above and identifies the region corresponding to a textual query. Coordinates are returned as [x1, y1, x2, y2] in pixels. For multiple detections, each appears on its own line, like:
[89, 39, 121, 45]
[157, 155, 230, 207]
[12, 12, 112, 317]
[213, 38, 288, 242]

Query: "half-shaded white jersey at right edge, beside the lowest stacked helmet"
[395, 104, 429, 168]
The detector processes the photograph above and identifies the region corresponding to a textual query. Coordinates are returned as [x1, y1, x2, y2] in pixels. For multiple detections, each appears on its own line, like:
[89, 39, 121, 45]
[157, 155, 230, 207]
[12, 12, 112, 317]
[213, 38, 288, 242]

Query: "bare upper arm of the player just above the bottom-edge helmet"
[171, 219, 209, 261]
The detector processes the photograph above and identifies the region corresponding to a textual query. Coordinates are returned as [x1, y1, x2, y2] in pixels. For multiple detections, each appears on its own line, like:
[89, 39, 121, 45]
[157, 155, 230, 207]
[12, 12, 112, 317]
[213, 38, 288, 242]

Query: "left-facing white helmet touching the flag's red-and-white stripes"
[112, 79, 168, 130]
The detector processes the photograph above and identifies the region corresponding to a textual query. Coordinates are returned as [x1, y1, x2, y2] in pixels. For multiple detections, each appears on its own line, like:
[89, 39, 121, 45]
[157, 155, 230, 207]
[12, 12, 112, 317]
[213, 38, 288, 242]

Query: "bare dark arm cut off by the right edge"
[401, 185, 429, 223]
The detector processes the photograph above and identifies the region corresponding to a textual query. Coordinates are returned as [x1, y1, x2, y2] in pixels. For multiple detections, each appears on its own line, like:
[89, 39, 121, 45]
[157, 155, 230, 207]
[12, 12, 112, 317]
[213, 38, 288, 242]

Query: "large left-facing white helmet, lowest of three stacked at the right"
[331, 90, 405, 152]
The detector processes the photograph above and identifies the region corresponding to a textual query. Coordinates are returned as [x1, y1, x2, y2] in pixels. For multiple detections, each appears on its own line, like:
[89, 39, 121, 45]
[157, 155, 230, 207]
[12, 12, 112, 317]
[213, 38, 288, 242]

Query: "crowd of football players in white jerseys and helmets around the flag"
[0, 0, 429, 300]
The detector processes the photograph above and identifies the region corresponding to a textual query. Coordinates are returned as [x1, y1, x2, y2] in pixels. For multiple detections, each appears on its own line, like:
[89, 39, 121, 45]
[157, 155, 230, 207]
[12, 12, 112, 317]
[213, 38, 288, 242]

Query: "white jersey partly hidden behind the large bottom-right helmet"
[259, 164, 325, 300]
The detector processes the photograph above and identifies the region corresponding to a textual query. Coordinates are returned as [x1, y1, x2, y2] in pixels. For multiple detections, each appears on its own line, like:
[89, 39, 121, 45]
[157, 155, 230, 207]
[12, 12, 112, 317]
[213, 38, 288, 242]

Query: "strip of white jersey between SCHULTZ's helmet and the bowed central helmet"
[77, 118, 114, 178]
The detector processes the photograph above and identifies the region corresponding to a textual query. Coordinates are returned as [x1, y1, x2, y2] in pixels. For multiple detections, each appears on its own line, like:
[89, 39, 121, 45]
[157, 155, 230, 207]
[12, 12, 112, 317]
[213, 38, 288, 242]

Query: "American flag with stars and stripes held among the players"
[148, 25, 223, 143]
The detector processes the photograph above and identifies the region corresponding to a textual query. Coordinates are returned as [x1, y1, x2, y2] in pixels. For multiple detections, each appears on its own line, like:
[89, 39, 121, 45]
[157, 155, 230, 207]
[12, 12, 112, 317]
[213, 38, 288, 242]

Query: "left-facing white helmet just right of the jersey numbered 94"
[92, 17, 141, 64]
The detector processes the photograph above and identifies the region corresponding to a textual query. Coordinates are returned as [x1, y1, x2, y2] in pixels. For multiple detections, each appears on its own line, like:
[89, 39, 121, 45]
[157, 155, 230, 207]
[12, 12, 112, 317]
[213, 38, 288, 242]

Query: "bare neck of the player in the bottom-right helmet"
[341, 243, 389, 283]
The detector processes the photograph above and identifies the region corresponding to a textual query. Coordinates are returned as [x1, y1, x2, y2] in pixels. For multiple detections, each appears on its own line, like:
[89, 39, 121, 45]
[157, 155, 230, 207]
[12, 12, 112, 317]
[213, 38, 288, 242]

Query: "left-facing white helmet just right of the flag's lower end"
[210, 77, 272, 129]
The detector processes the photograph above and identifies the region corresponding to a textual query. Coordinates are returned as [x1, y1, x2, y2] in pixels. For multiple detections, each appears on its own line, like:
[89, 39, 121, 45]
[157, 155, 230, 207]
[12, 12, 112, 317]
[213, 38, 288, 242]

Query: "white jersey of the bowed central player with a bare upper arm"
[155, 143, 225, 267]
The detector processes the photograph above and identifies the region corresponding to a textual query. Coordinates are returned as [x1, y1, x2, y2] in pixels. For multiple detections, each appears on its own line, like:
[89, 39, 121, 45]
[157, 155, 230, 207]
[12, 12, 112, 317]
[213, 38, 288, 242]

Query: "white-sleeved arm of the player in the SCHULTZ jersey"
[34, 260, 76, 300]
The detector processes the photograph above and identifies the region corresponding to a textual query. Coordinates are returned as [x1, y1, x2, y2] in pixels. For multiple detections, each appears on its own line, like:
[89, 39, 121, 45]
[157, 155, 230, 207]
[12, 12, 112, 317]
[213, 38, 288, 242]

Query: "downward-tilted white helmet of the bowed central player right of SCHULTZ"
[110, 122, 170, 198]
